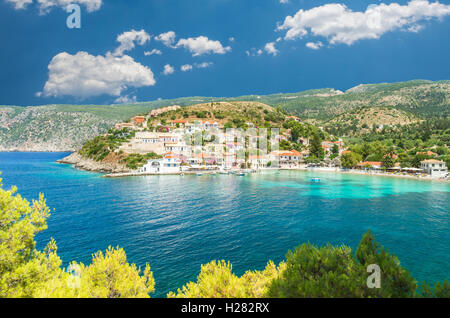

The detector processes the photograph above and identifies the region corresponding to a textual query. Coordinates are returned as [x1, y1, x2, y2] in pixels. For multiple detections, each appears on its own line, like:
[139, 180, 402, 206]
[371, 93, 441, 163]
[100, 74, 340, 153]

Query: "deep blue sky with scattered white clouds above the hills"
[0, 0, 450, 106]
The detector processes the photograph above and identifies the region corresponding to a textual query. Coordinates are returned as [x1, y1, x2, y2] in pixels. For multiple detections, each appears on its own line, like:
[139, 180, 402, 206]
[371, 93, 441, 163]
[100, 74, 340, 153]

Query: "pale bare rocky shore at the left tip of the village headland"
[57, 152, 131, 173]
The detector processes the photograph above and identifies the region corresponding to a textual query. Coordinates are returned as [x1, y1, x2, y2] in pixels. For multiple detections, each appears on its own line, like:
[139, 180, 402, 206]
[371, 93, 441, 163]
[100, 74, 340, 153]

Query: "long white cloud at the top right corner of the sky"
[278, 0, 450, 45]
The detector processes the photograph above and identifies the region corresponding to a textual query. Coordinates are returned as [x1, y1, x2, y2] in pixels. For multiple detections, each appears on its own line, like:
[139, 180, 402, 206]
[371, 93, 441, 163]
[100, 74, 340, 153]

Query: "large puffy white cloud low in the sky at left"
[42, 52, 156, 99]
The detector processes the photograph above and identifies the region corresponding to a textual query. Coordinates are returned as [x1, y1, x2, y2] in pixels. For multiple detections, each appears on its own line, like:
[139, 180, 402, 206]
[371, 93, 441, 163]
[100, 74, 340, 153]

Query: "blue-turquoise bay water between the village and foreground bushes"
[0, 153, 450, 297]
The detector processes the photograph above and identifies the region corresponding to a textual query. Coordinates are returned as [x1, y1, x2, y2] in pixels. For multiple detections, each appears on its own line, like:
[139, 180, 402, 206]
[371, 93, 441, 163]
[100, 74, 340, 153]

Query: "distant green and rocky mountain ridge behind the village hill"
[0, 80, 450, 151]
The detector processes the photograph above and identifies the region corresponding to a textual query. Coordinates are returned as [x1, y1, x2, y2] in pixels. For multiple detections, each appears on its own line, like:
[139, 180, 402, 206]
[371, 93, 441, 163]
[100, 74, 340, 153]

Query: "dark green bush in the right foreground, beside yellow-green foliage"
[269, 232, 416, 298]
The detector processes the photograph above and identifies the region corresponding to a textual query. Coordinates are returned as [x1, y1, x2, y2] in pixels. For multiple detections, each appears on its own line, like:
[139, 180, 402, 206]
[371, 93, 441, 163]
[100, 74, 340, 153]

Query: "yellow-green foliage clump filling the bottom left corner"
[0, 179, 154, 298]
